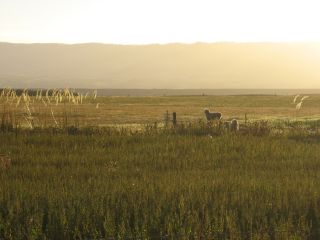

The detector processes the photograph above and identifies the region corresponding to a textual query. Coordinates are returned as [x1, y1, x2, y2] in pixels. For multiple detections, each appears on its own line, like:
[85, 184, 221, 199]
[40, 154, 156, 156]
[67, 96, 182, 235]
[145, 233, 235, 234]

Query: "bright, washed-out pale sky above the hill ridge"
[0, 0, 320, 44]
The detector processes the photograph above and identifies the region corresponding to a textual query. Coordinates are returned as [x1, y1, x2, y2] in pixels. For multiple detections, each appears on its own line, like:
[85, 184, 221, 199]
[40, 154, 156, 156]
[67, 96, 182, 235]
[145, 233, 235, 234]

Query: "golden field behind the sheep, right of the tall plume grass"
[67, 95, 320, 125]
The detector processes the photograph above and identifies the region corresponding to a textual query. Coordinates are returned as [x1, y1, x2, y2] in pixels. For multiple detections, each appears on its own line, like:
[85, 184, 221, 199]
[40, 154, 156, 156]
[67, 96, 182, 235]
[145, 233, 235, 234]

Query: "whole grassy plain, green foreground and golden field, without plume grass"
[0, 95, 320, 239]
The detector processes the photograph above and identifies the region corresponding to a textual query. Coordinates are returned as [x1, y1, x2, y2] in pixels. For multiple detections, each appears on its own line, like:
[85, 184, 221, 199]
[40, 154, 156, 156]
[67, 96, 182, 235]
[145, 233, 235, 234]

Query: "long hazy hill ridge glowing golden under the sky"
[0, 43, 320, 89]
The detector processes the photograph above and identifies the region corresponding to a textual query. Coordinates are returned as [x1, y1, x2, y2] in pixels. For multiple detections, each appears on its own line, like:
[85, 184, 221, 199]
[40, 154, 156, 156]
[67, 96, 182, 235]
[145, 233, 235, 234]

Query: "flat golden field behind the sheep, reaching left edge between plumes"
[0, 91, 320, 126]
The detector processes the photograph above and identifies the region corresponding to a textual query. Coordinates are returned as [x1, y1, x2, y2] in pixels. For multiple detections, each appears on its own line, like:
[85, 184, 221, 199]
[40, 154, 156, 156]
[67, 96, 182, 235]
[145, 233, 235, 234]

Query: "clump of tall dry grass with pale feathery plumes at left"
[0, 88, 99, 129]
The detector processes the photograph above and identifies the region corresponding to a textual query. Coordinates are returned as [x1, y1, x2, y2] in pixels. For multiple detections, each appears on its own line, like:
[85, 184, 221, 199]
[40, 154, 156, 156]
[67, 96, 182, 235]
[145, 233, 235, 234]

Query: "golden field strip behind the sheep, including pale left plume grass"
[0, 89, 320, 128]
